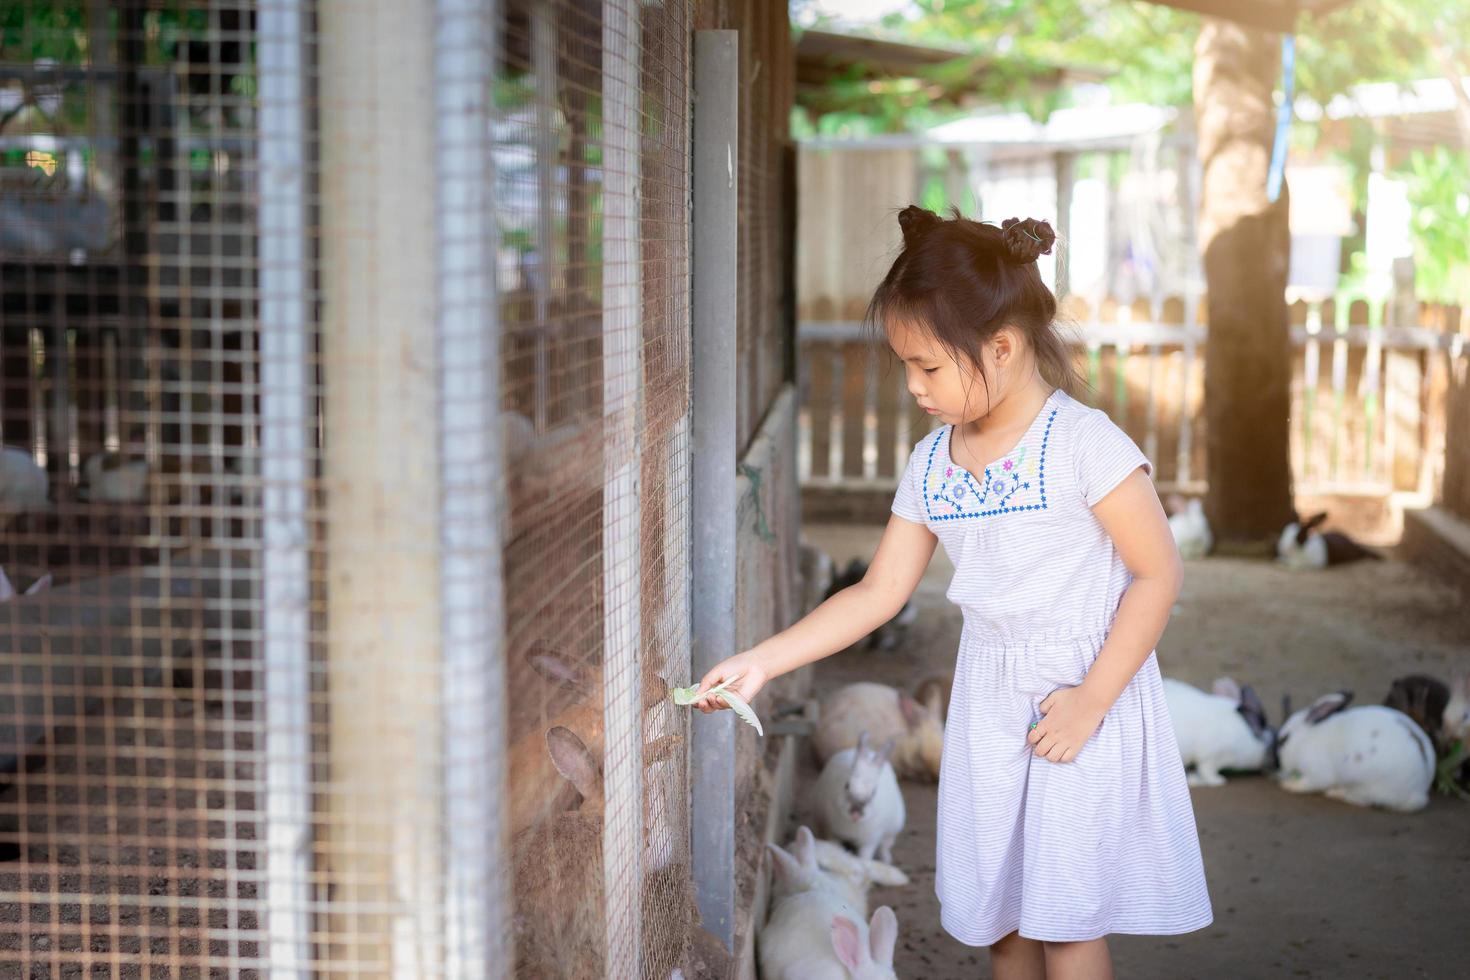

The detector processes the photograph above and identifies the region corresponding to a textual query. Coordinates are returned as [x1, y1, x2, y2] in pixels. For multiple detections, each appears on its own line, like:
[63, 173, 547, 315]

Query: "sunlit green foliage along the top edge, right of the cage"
[803, 0, 1470, 135]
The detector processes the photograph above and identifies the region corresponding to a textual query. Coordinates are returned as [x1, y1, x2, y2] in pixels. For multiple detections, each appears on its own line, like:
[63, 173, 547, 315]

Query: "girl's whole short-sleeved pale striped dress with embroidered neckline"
[892, 389, 1213, 946]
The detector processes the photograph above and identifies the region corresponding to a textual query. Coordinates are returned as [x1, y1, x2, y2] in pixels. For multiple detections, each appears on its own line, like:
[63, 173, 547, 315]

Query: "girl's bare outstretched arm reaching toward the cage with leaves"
[694, 516, 938, 714]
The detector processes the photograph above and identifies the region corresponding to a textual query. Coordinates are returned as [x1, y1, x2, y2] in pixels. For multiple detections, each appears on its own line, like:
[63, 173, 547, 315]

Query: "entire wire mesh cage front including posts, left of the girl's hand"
[0, 0, 699, 977]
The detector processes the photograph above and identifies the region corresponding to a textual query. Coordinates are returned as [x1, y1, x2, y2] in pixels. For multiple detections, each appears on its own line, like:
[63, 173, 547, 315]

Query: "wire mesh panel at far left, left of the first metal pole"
[0, 1, 273, 977]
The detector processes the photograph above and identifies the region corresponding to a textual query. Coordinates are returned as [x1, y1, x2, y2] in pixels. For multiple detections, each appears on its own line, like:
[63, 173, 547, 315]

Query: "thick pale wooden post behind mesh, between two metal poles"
[318, 0, 444, 976]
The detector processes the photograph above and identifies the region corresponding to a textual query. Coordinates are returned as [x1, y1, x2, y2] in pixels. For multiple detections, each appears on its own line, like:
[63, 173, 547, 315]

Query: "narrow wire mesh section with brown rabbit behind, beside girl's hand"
[495, 1, 692, 977]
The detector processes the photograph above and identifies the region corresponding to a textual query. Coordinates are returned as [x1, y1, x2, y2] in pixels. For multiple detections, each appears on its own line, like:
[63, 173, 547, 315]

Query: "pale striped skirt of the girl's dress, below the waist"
[935, 621, 1211, 946]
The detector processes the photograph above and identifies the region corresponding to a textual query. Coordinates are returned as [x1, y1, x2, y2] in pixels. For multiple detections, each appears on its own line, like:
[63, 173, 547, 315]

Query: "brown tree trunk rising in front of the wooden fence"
[1194, 19, 1292, 554]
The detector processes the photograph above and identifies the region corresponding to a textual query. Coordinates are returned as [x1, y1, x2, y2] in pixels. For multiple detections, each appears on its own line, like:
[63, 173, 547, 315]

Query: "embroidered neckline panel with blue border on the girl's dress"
[923, 408, 1057, 520]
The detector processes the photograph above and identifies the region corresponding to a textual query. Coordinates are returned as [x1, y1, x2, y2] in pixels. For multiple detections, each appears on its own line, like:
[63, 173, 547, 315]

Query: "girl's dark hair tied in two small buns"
[864, 204, 1083, 405]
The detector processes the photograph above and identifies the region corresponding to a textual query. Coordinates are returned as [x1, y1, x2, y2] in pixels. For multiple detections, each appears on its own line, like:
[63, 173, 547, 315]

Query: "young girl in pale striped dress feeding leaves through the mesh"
[695, 207, 1211, 980]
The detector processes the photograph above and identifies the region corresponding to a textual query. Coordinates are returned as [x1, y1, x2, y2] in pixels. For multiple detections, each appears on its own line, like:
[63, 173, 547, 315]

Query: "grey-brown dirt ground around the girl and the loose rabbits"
[786, 525, 1470, 980]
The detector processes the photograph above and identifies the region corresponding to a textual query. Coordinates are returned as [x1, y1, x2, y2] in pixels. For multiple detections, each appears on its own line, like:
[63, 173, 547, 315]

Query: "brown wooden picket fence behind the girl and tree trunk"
[798, 297, 1470, 498]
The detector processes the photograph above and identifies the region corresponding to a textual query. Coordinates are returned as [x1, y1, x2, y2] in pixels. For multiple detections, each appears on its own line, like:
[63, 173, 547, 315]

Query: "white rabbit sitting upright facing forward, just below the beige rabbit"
[813, 732, 907, 864]
